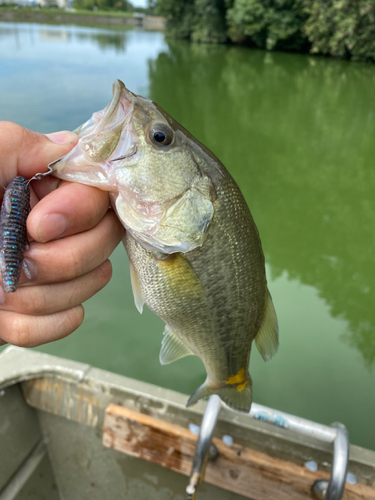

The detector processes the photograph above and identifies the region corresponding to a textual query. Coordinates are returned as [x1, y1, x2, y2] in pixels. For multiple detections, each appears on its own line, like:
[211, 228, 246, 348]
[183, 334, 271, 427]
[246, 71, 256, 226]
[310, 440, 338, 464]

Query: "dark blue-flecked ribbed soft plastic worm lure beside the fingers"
[0, 176, 30, 293]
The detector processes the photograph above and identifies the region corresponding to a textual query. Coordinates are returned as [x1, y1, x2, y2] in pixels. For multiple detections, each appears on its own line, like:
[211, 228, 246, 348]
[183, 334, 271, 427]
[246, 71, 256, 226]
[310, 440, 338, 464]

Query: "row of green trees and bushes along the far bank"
[156, 0, 375, 62]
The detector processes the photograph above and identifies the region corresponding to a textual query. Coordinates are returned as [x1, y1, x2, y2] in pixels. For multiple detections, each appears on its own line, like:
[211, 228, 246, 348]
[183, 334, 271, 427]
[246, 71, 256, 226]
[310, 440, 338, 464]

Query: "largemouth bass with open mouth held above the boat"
[53, 80, 279, 412]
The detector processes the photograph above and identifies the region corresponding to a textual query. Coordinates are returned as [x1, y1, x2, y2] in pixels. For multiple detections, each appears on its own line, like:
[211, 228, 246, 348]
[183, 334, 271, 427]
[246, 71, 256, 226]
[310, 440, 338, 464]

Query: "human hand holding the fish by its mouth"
[0, 122, 124, 347]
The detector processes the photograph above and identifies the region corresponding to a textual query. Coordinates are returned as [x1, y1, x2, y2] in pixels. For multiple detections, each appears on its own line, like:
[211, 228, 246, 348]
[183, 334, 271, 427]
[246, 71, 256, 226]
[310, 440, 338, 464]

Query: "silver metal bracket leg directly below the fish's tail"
[186, 395, 221, 500]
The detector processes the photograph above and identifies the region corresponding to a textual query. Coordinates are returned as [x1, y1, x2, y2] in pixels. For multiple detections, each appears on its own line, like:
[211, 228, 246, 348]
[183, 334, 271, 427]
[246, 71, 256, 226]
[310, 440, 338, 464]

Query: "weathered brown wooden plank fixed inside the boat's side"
[103, 404, 375, 500]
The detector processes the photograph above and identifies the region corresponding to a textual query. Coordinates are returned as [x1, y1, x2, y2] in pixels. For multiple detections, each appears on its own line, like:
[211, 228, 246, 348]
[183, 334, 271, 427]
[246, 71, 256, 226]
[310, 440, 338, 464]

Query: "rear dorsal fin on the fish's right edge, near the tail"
[255, 289, 279, 361]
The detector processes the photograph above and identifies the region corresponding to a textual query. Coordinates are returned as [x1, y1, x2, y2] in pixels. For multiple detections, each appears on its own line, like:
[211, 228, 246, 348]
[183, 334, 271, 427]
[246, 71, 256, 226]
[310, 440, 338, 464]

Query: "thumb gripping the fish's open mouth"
[0, 122, 78, 186]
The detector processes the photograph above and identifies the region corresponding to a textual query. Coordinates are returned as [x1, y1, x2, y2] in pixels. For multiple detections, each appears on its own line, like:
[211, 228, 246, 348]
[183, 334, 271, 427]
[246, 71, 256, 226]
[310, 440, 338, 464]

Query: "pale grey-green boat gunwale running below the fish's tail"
[0, 346, 375, 487]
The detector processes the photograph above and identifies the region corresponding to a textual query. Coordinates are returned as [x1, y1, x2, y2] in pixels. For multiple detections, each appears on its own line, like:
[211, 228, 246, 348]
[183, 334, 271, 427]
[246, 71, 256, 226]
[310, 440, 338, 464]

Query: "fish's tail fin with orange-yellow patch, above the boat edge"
[186, 378, 252, 413]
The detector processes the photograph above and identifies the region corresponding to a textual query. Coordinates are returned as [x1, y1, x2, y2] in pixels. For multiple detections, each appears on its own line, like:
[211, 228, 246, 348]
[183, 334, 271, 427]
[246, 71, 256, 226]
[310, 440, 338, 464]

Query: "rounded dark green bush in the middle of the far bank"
[227, 0, 308, 51]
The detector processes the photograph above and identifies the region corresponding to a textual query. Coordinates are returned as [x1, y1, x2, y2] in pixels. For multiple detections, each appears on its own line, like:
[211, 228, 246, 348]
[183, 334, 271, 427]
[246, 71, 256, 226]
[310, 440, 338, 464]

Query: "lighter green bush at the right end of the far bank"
[304, 0, 375, 60]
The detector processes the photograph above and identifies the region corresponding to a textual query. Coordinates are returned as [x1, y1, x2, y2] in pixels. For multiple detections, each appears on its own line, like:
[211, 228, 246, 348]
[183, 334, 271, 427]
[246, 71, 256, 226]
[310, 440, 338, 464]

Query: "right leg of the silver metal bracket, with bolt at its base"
[311, 423, 349, 500]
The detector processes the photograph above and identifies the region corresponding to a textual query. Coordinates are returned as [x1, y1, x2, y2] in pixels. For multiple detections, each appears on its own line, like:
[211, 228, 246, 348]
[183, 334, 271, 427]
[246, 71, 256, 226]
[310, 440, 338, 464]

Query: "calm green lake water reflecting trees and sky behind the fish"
[0, 23, 375, 449]
